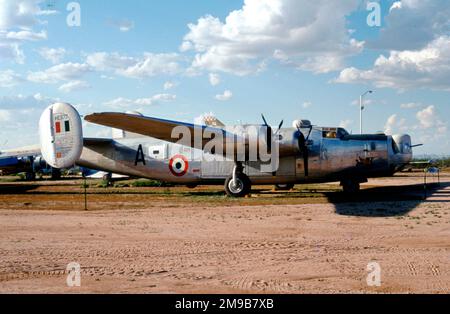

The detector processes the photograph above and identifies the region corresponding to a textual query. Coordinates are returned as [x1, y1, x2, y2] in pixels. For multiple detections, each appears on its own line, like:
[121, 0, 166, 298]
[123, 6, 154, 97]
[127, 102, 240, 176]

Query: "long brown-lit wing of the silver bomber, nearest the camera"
[85, 112, 244, 152]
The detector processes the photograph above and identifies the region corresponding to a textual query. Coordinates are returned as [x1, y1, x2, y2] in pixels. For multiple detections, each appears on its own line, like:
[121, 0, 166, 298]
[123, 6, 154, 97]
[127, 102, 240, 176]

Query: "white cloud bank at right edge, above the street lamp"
[335, 36, 450, 91]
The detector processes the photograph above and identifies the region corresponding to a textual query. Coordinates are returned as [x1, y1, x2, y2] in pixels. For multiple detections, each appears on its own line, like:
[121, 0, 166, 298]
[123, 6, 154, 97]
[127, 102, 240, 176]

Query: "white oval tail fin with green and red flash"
[39, 103, 83, 169]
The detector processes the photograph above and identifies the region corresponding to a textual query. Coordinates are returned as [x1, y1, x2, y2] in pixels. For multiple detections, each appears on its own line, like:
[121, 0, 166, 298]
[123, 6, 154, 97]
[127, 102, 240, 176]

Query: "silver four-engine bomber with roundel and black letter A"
[0, 103, 414, 197]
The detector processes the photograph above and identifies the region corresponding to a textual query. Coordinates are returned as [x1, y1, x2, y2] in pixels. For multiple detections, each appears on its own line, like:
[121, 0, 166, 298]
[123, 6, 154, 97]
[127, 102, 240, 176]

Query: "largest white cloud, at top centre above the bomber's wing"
[180, 0, 363, 75]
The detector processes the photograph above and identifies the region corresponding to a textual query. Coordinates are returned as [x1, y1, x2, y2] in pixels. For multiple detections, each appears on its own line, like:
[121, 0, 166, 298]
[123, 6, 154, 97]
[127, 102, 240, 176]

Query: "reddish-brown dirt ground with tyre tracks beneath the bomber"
[0, 174, 450, 293]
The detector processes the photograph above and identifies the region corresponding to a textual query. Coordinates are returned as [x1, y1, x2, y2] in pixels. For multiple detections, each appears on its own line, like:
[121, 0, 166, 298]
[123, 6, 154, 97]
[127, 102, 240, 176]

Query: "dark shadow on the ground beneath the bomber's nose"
[326, 183, 450, 217]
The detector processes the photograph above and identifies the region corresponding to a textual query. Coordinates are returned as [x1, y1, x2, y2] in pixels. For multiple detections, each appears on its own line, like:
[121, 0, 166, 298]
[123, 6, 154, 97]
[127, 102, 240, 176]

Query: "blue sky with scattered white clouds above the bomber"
[0, 0, 450, 155]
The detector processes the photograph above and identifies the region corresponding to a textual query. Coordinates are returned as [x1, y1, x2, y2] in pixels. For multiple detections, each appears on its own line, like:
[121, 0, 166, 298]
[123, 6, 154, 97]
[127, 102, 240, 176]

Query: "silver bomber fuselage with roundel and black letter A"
[77, 128, 412, 184]
